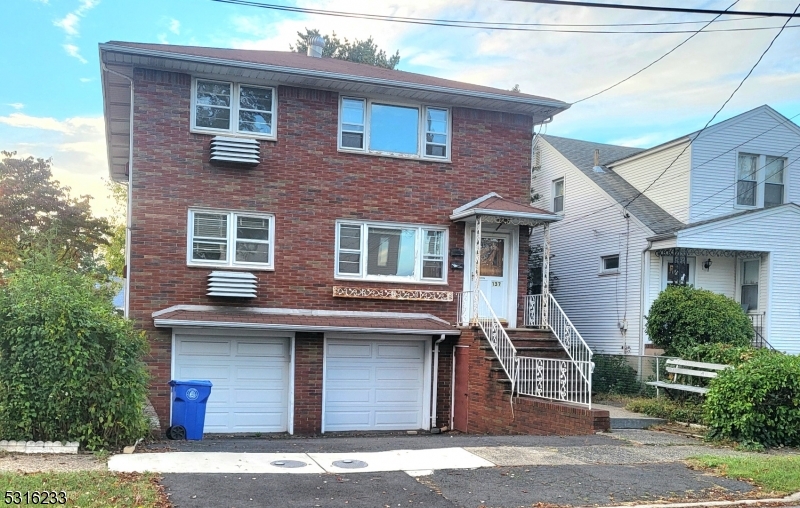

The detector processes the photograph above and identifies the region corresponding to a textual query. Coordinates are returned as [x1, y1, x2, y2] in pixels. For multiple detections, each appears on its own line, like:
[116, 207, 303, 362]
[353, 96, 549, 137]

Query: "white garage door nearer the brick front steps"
[324, 339, 428, 431]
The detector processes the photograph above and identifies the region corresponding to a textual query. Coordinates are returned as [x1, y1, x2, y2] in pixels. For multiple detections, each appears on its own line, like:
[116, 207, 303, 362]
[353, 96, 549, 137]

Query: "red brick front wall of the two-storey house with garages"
[129, 69, 532, 433]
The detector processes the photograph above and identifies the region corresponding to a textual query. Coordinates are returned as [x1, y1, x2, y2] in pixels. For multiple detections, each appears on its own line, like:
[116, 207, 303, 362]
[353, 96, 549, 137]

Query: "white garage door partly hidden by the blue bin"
[174, 335, 290, 433]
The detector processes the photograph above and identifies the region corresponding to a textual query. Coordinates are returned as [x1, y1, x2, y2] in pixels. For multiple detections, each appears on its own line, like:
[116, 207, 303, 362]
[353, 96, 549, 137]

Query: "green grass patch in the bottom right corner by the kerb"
[694, 455, 800, 494]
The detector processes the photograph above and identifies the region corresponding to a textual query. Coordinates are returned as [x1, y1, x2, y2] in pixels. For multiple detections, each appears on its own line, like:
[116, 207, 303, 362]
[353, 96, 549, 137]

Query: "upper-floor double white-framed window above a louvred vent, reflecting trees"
[191, 78, 277, 139]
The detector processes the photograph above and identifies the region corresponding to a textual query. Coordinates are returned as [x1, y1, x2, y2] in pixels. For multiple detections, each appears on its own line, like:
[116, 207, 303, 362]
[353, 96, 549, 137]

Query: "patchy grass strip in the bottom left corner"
[0, 471, 171, 508]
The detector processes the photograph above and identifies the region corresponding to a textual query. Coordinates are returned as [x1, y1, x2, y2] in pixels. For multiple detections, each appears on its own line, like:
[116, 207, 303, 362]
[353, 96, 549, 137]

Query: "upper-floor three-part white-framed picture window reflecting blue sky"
[339, 97, 451, 161]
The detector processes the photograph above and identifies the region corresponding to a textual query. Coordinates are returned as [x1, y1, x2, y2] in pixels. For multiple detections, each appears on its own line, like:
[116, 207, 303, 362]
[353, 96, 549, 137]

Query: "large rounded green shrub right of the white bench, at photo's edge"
[705, 350, 800, 447]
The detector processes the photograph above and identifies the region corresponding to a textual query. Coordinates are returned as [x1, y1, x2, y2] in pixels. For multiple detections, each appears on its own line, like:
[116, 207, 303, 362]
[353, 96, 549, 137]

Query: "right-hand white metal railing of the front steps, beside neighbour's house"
[525, 294, 593, 384]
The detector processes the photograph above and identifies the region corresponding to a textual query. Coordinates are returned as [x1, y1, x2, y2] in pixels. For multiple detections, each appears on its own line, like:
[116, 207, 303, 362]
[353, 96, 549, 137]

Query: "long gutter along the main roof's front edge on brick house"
[100, 43, 570, 111]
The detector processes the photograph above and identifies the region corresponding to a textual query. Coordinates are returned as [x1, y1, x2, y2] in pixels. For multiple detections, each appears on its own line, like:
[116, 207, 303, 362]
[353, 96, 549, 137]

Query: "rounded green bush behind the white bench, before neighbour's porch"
[646, 286, 753, 356]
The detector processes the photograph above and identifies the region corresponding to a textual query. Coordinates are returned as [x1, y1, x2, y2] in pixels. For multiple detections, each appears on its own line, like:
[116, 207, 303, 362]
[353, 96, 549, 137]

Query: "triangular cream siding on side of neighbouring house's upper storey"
[601, 143, 694, 222]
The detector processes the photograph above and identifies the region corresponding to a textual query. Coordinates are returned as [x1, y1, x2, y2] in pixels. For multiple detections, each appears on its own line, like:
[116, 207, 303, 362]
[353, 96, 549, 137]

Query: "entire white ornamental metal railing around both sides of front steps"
[456, 290, 592, 409]
